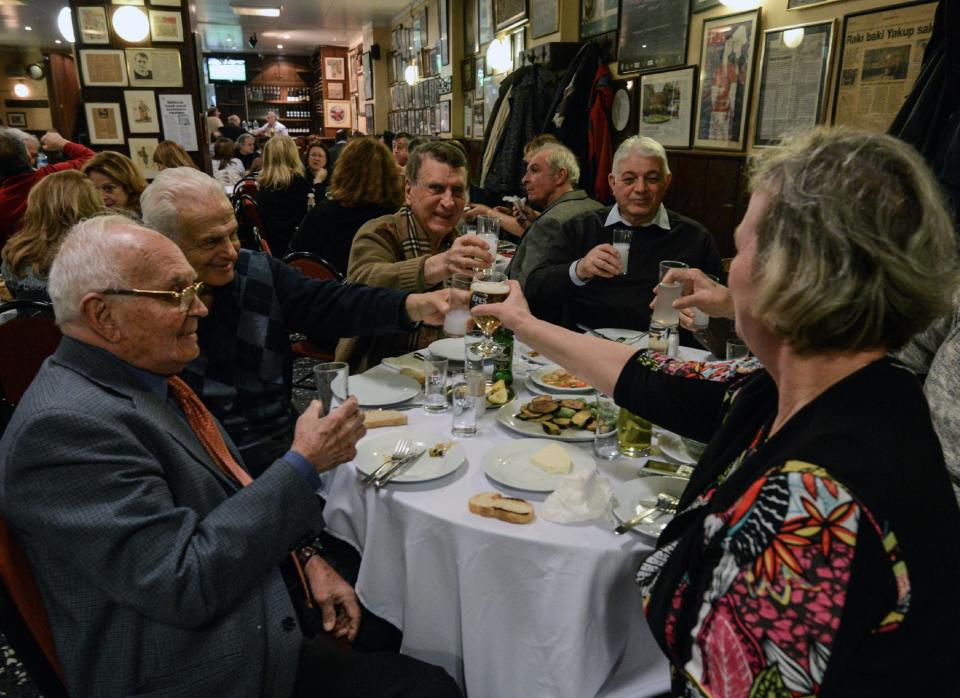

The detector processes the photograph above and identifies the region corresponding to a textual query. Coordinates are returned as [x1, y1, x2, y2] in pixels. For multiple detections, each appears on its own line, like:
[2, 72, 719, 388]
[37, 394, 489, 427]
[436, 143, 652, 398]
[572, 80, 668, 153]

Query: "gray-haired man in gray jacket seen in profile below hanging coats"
[507, 143, 603, 286]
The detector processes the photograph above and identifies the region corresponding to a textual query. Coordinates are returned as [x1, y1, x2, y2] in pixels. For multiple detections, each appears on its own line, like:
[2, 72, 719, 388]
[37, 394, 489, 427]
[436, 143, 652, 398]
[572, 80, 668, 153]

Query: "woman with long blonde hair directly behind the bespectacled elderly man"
[2, 170, 104, 301]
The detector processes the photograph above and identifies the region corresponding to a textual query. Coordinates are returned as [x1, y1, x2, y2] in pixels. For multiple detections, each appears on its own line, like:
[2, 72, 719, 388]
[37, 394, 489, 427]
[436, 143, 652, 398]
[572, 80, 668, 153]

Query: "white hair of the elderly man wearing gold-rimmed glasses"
[47, 215, 140, 325]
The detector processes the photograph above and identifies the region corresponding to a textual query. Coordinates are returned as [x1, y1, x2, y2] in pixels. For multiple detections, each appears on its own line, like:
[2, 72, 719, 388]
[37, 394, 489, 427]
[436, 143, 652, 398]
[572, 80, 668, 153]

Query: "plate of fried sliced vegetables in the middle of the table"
[497, 394, 616, 441]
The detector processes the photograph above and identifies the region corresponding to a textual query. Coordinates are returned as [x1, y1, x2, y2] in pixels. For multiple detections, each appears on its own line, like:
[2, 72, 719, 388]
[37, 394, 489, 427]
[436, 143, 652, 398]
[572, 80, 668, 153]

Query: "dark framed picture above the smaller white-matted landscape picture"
[617, 0, 690, 75]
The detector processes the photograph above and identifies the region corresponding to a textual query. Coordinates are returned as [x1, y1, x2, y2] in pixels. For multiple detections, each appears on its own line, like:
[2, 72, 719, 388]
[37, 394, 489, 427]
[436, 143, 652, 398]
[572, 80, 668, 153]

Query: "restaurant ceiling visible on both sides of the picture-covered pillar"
[0, 0, 411, 54]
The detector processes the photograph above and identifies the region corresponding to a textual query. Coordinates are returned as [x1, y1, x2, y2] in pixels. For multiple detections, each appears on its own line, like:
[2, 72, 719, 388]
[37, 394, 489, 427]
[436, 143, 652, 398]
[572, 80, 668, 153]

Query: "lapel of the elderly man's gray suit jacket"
[52, 337, 243, 492]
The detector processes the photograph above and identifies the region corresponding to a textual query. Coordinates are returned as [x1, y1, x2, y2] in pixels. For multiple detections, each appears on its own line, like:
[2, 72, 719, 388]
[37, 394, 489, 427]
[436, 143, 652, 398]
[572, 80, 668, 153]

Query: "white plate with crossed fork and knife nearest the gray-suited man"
[353, 428, 467, 482]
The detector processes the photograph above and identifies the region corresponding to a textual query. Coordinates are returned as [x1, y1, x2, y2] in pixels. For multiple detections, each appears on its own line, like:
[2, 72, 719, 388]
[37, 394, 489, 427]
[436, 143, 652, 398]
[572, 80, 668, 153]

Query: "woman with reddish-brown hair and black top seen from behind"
[290, 138, 403, 274]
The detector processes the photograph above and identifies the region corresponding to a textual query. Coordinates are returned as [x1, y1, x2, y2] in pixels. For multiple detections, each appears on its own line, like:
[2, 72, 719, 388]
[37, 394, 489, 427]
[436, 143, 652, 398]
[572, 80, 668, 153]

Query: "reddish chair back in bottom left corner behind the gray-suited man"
[0, 519, 67, 698]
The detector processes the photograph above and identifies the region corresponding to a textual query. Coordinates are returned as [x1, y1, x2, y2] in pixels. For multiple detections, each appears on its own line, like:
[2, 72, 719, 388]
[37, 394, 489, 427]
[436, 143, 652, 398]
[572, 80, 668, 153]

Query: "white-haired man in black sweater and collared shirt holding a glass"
[524, 136, 722, 330]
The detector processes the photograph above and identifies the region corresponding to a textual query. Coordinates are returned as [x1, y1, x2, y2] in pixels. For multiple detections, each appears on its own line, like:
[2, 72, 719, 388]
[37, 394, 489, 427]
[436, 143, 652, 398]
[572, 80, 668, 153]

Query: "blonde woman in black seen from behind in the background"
[257, 135, 310, 257]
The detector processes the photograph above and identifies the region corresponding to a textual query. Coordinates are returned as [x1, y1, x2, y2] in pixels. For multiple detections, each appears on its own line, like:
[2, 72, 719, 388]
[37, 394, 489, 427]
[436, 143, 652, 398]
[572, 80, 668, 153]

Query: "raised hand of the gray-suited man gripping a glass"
[290, 396, 367, 473]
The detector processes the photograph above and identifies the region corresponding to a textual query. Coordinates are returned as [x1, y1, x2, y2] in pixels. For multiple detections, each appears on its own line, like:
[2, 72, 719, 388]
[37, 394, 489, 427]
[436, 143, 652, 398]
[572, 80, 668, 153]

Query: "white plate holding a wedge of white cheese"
[481, 439, 597, 492]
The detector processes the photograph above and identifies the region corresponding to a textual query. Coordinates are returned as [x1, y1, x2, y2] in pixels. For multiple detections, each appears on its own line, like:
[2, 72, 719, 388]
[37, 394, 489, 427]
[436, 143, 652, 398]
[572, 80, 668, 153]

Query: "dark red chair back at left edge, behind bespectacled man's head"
[0, 300, 63, 405]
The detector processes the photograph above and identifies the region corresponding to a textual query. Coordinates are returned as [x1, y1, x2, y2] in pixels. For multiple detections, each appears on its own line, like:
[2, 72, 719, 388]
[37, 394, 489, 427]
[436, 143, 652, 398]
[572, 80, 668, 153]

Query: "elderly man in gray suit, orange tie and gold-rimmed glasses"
[0, 216, 458, 698]
